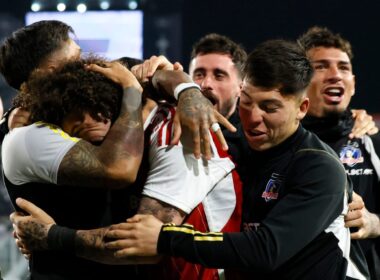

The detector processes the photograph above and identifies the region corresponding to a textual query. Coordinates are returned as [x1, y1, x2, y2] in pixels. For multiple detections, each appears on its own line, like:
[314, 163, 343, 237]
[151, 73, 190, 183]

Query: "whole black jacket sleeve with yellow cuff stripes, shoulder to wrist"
[157, 150, 347, 271]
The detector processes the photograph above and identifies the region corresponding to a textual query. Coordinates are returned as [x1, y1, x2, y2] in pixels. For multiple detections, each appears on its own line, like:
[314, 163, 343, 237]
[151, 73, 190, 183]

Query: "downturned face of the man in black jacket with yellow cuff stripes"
[239, 80, 308, 151]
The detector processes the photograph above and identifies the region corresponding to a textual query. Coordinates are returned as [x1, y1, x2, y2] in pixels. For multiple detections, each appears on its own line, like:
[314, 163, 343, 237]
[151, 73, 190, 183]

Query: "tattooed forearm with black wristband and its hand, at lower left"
[10, 198, 160, 264]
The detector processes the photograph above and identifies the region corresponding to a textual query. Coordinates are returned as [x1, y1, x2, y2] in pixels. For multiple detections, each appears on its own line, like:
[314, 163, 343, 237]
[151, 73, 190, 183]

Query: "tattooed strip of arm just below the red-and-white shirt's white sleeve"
[138, 196, 186, 224]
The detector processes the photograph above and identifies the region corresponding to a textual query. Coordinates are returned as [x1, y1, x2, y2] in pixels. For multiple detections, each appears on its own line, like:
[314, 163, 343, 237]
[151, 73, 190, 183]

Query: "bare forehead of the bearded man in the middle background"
[191, 53, 235, 70]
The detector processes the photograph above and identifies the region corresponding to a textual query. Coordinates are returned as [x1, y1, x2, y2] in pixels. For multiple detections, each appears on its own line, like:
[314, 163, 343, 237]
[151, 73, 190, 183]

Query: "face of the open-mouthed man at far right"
[307, 47, 355, 117]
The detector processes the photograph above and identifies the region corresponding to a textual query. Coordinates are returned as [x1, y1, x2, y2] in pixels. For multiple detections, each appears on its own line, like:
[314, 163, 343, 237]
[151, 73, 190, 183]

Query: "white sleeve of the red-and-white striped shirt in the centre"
[143, 137, 234, 214]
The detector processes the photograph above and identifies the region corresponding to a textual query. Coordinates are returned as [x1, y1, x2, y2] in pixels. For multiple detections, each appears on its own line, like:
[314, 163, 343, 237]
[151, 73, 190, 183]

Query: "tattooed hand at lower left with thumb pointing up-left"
[10, 198, 55, 250]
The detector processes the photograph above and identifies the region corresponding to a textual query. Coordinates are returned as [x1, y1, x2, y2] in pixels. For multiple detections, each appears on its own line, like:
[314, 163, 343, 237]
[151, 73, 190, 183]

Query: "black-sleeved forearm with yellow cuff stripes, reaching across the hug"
[157, 222, 276, 271]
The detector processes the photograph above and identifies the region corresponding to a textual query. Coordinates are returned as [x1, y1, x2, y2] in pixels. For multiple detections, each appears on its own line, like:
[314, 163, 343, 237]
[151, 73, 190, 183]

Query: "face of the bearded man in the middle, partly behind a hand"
[190, 53, 241, 118]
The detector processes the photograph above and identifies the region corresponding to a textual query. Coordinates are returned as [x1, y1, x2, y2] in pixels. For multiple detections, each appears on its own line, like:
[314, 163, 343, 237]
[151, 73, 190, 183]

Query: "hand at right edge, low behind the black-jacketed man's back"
[345, 193, 380, 239]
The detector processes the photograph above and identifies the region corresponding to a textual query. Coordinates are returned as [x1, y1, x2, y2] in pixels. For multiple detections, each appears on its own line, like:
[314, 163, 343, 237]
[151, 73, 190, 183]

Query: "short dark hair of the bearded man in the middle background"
[191, 33, 247, 74]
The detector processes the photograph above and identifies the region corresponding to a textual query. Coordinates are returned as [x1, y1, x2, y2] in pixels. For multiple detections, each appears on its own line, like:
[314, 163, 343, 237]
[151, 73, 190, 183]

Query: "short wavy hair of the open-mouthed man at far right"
[298, 26, 354, 60]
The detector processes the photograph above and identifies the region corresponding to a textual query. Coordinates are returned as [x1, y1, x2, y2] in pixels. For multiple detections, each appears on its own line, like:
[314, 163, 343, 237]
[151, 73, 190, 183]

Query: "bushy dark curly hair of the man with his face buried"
[13, 57, 123, 126]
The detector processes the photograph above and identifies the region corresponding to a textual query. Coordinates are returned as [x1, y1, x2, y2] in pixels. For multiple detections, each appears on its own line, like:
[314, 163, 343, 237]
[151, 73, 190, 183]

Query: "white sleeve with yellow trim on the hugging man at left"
[2, 123, 80, 185]
